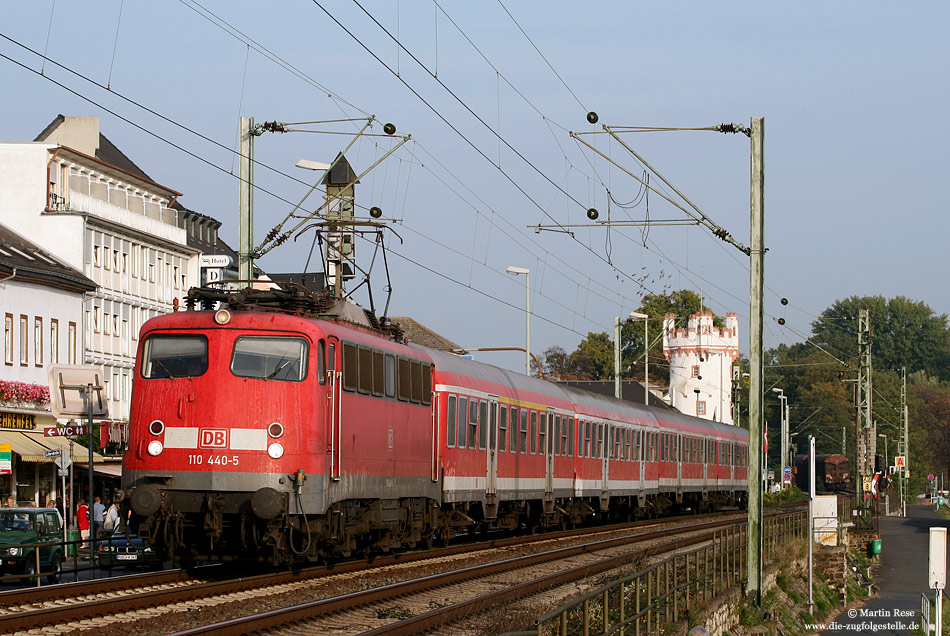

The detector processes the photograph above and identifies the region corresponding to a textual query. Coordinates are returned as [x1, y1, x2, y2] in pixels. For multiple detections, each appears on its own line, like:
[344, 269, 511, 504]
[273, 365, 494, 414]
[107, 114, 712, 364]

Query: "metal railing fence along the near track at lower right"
[502, 511, 808, 636]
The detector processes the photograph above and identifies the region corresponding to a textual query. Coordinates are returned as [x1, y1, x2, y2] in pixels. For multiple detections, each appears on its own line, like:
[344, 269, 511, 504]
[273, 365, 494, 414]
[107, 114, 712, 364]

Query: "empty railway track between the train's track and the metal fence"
[165, 519, 768, 636]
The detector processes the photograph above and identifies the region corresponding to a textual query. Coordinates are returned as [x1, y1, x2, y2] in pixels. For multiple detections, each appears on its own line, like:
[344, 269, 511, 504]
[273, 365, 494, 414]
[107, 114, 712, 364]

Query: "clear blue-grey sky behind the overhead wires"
[0, 0, 950, 369]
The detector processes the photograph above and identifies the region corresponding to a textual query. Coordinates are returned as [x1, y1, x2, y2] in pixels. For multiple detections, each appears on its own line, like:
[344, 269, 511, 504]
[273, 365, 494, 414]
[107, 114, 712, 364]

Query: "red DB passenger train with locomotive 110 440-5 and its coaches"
[117, 285, 749, 565]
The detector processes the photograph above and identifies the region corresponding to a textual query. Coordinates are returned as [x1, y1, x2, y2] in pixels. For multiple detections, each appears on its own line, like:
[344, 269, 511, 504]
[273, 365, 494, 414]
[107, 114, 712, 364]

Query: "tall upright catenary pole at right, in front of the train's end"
[746, 117, 765, 607]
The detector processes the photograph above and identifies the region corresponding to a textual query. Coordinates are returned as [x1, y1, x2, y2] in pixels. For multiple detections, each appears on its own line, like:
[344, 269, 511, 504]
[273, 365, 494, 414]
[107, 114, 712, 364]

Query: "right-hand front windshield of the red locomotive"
[231, 336, 309, 382]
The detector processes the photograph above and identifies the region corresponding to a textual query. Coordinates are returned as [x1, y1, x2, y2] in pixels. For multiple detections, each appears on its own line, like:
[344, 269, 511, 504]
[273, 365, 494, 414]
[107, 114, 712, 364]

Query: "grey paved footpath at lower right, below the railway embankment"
[821, 505, 950, 636]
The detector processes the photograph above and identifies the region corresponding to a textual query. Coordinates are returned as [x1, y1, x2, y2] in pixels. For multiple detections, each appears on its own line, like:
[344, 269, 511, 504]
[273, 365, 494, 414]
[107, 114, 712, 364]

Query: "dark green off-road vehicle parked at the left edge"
[0, 508, 63, 585]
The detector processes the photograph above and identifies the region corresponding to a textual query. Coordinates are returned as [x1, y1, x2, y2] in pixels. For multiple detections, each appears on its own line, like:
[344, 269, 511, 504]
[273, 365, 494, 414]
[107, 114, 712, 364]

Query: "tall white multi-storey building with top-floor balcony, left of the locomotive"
[0, 117, 199, 420]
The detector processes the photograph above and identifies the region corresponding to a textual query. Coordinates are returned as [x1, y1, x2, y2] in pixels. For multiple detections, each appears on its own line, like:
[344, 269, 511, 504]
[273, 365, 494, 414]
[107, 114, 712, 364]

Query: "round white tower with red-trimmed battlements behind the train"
[663, 313, 739, 424]
